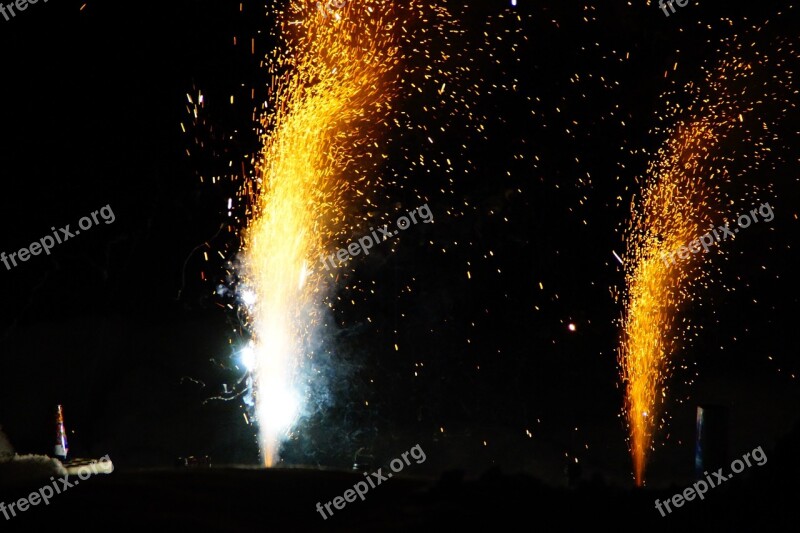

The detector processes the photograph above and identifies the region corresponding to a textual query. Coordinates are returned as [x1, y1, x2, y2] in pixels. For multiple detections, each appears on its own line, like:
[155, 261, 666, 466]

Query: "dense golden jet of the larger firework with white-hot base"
[241, 0, 416, 466]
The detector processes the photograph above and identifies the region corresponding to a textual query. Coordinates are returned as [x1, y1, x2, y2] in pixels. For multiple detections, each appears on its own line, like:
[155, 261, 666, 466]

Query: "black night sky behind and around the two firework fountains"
[0, 0, 800, 502]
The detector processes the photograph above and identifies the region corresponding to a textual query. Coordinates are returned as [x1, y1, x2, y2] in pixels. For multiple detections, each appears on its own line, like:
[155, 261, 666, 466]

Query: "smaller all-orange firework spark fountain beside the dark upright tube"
[619, 38, 791, 486]
